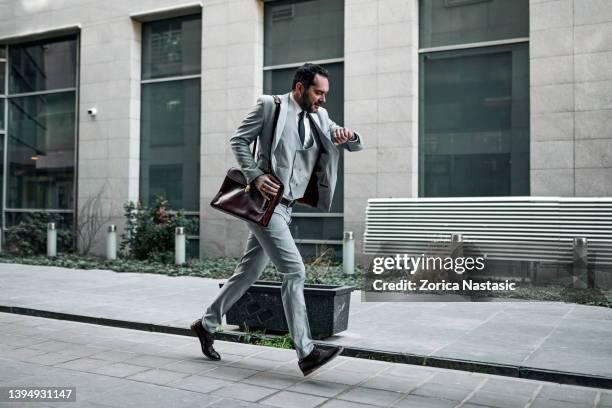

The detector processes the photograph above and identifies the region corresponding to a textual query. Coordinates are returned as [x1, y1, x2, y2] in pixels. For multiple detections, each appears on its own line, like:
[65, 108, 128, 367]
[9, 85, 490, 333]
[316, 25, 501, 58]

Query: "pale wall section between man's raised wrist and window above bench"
[344, 0, 418, 258]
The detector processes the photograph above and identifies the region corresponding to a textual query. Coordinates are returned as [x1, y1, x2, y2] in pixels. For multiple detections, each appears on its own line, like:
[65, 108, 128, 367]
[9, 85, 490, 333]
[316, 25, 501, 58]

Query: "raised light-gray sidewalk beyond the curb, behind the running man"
[0, 264, 612, 387]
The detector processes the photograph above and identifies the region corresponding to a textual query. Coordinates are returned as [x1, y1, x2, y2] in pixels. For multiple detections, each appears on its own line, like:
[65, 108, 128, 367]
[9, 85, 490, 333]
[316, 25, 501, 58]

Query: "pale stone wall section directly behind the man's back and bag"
[200, 0, 263, 257]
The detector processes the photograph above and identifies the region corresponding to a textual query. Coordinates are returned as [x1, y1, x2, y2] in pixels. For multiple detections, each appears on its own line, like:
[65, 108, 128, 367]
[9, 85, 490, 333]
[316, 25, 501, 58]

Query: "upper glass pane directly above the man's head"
[264, 0, 344, 66]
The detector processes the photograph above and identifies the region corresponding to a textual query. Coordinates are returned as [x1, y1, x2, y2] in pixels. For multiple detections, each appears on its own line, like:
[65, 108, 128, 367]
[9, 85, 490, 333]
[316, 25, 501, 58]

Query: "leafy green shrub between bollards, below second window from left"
[120, 197, 198, 263]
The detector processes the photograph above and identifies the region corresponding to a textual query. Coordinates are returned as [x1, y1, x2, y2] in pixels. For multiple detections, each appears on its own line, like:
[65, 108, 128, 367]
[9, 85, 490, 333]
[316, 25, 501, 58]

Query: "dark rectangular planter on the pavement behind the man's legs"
[219, 281, 354, 339]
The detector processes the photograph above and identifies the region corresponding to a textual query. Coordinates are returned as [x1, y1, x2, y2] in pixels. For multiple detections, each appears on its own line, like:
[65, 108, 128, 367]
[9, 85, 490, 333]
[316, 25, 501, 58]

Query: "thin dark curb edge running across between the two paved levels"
[0, 305, 612, 389]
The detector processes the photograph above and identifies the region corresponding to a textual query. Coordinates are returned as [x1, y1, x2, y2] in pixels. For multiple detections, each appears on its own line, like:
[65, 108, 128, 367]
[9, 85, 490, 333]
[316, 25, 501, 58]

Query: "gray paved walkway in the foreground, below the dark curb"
[0, 313, 612, 408]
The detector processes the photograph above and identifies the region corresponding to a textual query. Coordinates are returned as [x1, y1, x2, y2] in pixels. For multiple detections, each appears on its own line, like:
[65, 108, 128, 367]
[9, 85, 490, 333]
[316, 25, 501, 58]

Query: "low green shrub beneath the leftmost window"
[6, 211, 73, 255]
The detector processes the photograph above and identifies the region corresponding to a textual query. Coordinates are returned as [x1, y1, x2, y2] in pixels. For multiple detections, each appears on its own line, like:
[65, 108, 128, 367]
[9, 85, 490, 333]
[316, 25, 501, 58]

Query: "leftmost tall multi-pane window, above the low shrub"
[0, 36, 78, 228]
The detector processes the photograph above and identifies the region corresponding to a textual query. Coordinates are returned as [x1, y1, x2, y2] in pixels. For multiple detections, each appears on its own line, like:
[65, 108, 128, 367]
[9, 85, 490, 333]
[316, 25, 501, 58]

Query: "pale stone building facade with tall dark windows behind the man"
[0, 0, 612, 257]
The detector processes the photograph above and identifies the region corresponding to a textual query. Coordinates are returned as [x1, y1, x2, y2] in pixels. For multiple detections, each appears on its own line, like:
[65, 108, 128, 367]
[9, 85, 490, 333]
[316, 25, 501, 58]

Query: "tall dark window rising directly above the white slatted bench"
[419, 0, 529, 197]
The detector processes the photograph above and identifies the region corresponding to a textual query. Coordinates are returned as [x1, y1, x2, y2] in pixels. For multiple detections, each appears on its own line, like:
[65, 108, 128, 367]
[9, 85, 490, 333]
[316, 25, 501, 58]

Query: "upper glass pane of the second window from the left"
[142, 15, 202, 79]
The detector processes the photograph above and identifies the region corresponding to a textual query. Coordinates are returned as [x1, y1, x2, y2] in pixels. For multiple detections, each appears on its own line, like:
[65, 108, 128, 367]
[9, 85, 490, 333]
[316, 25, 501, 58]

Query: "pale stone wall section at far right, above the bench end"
[530, 0, 612, 197]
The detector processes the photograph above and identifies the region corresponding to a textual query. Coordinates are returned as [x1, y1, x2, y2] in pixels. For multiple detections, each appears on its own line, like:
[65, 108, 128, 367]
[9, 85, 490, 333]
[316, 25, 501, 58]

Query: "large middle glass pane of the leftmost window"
[7, 91, 75, 209]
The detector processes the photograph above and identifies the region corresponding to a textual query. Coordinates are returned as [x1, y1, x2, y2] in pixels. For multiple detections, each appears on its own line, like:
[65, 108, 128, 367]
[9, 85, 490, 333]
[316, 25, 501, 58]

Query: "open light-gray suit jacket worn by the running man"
[230, 93, 363, 211]
